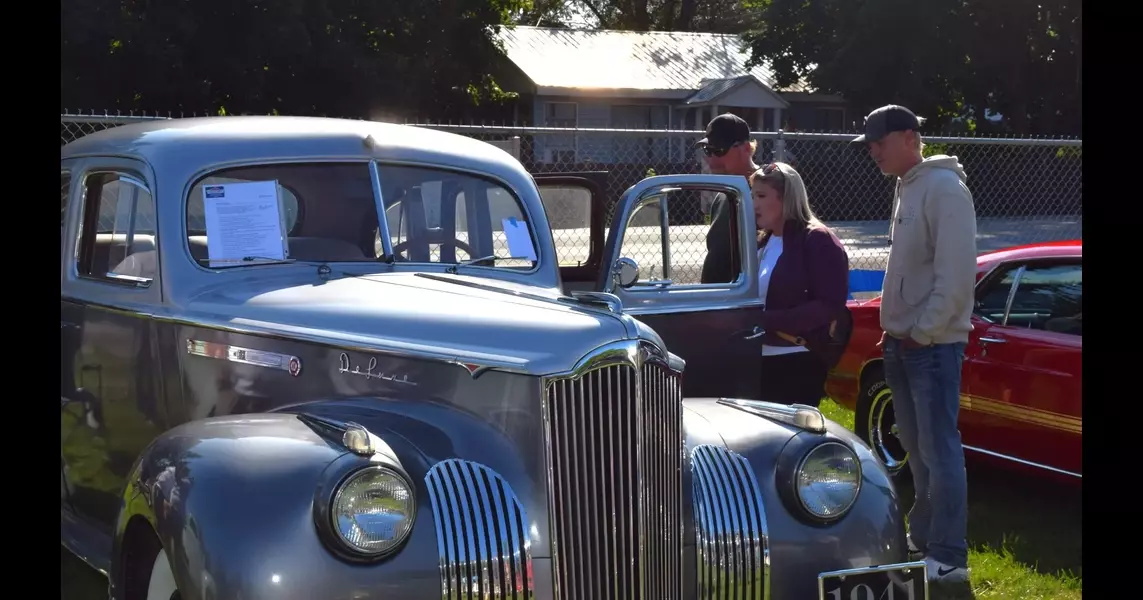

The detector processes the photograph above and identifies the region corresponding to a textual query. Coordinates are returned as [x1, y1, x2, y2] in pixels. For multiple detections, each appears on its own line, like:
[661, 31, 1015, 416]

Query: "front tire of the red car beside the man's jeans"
[854, 366, 912, 483]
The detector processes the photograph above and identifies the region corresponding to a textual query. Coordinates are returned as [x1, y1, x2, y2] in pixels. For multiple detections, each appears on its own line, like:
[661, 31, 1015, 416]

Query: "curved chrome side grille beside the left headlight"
[425, 458, 535, 600]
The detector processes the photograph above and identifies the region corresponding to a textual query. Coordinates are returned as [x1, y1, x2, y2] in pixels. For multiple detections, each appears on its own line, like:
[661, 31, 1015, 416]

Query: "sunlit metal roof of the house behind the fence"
[496, 25, 802, 98]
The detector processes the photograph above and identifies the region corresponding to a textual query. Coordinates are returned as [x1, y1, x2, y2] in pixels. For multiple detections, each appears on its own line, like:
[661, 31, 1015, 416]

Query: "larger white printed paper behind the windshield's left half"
[202, 181, 288, 266]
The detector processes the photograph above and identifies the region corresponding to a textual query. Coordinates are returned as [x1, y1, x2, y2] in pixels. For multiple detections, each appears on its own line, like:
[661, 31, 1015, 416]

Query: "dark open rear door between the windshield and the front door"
[533, 171, 607, 294]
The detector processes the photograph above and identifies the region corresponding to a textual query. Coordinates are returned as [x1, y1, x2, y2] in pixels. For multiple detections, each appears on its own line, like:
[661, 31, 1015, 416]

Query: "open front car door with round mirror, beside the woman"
[596, 175, 762, 399]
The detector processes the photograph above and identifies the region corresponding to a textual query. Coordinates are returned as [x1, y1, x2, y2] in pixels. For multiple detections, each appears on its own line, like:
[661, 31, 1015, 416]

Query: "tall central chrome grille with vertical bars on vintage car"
[545, 362, 682, 600]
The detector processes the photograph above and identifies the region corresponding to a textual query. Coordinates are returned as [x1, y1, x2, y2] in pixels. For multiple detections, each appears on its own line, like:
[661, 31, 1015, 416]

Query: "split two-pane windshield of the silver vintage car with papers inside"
[186, 162, 536, 270]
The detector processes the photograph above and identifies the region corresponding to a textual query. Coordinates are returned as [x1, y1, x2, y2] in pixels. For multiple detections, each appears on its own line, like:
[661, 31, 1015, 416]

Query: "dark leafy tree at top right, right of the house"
[744, 0, 1081, 134]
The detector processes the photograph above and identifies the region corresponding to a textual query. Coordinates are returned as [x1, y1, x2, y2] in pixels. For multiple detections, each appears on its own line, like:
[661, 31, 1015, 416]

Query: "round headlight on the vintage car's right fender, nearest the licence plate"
[794, 441, 861, 520]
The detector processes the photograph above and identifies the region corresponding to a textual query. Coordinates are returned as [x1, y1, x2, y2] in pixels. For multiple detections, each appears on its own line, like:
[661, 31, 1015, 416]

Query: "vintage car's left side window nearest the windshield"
[77, 171, 157, 286]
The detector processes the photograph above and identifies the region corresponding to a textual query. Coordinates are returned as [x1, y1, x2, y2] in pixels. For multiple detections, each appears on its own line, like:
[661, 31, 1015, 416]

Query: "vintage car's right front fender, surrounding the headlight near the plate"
[684, 398, 908, 598]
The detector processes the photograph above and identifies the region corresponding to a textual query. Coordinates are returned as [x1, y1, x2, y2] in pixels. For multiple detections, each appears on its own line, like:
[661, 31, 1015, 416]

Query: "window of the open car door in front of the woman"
[620, 189, 742, 289]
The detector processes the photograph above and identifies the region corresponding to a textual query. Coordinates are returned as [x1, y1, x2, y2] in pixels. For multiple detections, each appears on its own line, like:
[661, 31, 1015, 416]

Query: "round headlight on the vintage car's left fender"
[330, 466, 416, 557]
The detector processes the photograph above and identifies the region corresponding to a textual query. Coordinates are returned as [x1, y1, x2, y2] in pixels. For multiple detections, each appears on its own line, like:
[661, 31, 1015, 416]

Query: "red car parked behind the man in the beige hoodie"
[826, 240, 1084, 485]
